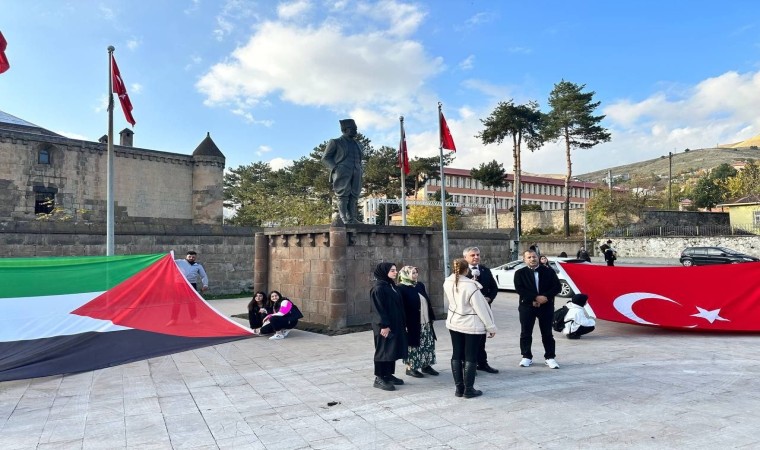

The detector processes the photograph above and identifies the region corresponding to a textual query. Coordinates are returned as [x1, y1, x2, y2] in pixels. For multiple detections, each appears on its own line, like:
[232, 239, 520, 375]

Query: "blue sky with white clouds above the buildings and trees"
[0, 0, 760, 178]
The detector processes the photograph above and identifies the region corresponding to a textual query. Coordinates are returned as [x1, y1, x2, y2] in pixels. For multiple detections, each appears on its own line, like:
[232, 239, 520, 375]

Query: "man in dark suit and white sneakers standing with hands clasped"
[515, 250, 562, 369]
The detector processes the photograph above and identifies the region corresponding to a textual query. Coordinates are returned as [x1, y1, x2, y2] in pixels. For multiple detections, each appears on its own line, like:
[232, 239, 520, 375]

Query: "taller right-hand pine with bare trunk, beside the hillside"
[543, 80, 611, 236]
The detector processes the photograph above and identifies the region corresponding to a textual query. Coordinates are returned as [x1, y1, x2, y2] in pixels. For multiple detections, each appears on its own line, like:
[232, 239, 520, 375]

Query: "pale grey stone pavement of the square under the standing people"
[0, 292, 760, 450]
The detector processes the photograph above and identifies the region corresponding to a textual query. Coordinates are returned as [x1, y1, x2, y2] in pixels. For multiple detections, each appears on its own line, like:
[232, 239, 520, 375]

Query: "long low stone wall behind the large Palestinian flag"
[0, 222, 254, 295]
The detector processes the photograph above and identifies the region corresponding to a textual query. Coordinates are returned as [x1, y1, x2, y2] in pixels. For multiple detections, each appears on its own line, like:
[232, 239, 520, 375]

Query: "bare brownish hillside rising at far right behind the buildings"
[577, 148, 760, 185]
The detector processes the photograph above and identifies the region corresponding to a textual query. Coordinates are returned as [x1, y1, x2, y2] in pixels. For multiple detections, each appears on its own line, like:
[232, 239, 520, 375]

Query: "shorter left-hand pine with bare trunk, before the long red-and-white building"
[475, 100, 544, 239]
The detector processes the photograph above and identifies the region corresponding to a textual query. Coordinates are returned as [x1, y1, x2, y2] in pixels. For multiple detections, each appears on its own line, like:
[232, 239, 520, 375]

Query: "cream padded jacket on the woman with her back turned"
[443, 274, 496, 334]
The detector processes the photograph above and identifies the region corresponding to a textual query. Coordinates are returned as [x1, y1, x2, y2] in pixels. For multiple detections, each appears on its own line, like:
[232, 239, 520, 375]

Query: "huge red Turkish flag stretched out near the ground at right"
[562, 262, 760, 332]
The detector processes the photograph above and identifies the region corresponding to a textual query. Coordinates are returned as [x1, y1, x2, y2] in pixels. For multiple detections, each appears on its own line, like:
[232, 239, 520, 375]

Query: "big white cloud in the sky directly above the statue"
[196, 2, 443, 128]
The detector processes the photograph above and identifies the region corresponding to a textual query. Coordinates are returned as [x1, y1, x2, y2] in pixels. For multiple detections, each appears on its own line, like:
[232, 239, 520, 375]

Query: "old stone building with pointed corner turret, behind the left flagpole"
[0, 111, 225, 225]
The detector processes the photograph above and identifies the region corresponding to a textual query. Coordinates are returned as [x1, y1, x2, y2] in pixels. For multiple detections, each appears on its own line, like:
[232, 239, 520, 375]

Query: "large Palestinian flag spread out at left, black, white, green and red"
[0, 254, 252, 381]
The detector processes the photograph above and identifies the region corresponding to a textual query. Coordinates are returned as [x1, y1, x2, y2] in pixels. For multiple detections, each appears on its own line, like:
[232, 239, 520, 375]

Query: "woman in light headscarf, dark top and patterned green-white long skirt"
[398, 266, 438, 378]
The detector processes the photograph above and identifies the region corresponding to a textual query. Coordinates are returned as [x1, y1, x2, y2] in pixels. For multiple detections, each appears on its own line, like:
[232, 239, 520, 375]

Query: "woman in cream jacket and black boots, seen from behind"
[443, 259, 496, 398]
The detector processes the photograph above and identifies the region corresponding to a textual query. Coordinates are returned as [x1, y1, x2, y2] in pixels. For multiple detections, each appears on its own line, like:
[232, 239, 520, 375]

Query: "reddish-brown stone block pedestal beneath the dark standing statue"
[254, 225, 509, 329]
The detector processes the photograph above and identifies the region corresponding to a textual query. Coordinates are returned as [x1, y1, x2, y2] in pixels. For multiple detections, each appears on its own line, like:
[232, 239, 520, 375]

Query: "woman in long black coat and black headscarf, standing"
[369, 263, 407, 391]
